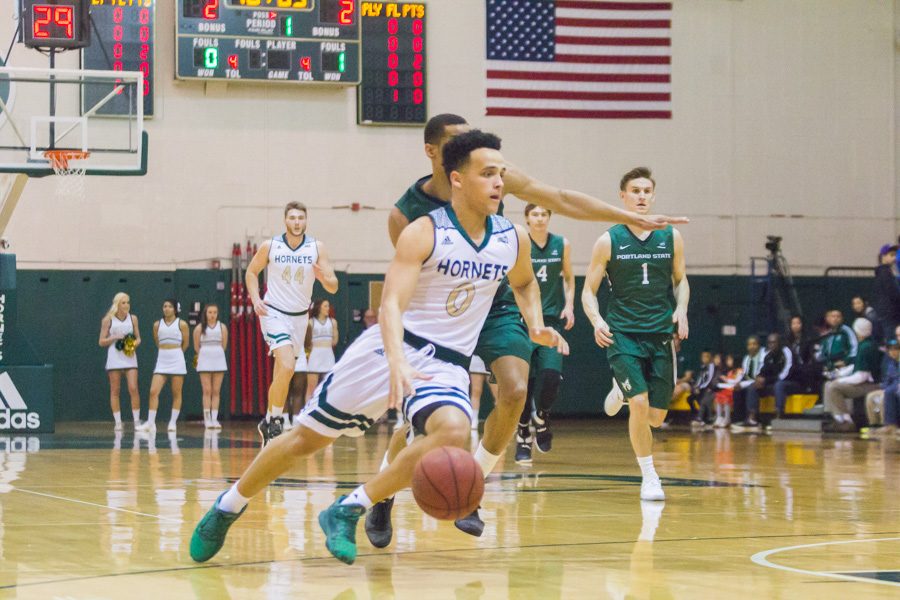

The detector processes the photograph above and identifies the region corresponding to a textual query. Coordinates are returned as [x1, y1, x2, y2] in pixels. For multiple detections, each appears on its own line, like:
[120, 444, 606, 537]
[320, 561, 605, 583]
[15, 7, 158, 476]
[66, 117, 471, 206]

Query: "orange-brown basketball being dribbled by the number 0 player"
[412, 446, 484, 521]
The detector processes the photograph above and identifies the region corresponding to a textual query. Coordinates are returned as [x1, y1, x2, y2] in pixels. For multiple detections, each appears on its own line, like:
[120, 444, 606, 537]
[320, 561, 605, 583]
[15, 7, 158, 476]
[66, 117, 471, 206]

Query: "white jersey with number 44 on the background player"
[263, 235, 319, 314]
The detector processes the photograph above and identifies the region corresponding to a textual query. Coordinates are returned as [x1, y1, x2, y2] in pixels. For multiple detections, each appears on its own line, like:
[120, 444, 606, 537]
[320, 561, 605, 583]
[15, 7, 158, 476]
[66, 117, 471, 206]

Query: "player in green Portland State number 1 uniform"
[581, 167, 691, 500]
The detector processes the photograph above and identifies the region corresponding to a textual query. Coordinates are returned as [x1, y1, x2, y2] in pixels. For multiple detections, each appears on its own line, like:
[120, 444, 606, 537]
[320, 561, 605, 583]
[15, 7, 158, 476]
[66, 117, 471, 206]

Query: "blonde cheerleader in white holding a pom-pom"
[100, 292, 141, 431]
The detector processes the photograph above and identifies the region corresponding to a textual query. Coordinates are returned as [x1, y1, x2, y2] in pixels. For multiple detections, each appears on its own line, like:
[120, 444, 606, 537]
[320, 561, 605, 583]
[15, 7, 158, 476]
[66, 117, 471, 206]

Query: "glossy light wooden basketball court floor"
[0, 421, 900, 600]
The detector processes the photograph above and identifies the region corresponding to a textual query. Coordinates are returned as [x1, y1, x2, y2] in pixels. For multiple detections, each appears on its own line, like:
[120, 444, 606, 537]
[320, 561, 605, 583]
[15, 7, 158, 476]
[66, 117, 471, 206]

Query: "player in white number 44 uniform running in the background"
[245, 202, 338, 446]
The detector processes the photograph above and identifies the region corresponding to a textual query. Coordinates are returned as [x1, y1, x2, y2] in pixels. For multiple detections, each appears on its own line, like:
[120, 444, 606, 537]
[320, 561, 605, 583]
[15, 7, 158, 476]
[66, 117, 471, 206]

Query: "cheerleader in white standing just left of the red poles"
[194, 304, 228, 429]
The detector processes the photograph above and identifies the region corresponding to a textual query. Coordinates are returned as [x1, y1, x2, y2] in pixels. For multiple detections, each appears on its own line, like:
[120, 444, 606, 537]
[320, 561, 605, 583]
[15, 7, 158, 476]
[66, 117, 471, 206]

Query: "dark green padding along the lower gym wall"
[18, 270, 872, 422]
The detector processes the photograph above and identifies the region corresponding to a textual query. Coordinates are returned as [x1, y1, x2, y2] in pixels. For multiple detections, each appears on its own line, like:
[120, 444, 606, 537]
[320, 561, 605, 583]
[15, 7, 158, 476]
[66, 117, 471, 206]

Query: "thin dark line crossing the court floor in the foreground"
[7, 531, 900, 590]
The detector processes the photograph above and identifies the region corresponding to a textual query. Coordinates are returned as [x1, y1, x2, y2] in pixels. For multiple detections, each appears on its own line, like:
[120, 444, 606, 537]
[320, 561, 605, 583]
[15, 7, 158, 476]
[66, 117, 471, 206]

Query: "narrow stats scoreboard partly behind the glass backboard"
[81, 0, 159, 117]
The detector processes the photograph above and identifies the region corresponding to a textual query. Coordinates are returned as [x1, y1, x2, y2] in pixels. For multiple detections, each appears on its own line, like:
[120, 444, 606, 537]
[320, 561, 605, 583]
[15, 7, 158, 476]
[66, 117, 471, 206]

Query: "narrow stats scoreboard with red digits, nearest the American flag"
[356, 2, 428, 125]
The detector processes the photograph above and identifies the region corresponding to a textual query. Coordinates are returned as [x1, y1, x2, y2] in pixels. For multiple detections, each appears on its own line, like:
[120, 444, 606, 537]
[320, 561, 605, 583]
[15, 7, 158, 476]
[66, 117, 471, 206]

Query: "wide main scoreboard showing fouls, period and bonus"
[176, 0, 360, 85]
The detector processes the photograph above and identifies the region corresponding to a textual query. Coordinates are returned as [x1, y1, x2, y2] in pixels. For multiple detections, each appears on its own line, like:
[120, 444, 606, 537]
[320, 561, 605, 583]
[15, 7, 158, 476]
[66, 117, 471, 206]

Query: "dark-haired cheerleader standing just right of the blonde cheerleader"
[146, 300, 190, 432]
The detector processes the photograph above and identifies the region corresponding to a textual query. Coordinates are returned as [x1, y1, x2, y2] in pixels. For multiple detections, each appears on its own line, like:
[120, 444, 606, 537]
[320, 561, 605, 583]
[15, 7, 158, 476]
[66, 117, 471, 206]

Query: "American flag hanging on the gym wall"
[486, 0, 672, 119]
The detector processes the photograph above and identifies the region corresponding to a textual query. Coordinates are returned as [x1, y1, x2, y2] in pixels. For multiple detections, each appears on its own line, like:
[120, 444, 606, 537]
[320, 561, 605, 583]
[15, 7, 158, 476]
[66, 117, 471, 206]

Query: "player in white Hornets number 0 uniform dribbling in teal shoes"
[191, 131, 568, 563]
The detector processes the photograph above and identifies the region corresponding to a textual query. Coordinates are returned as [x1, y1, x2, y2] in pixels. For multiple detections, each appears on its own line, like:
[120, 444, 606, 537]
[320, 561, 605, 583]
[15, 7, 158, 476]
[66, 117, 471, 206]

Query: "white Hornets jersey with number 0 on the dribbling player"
[403, 206, 519, 356]
